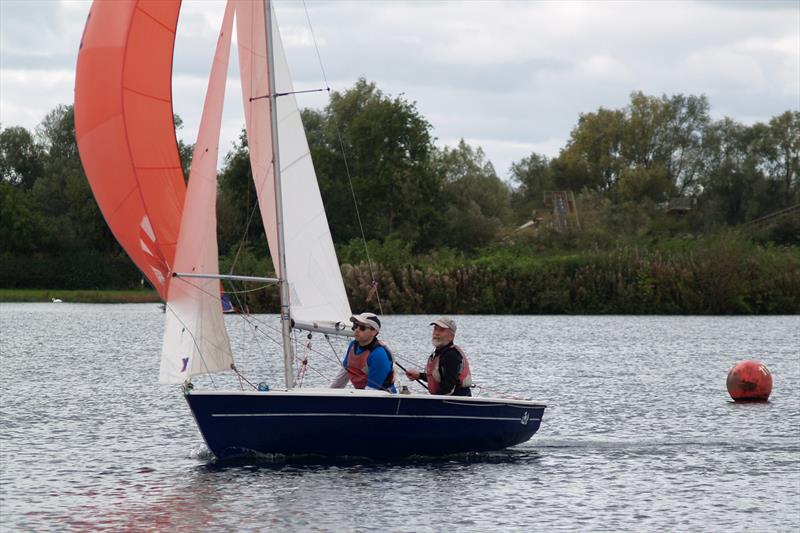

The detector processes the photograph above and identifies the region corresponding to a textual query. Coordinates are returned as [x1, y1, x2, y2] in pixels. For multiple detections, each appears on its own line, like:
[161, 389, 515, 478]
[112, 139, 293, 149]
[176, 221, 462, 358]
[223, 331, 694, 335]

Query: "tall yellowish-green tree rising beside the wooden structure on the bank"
[552, 92, 710, 202]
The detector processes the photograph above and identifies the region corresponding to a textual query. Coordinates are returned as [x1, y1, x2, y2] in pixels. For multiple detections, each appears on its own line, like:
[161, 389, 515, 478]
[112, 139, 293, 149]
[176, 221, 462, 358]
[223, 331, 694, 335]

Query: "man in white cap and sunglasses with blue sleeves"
[331, 313, 397, 393]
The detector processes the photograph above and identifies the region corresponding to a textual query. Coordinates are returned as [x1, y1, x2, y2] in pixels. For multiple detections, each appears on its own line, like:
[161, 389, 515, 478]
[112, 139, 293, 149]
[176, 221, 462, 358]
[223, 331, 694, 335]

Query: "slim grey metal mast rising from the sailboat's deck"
[264, 0, 294, 390]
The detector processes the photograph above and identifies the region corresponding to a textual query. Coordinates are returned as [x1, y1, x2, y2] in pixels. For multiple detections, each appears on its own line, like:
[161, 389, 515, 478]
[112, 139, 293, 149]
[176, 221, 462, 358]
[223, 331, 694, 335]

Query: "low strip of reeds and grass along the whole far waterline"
[0, 234, 800, 315]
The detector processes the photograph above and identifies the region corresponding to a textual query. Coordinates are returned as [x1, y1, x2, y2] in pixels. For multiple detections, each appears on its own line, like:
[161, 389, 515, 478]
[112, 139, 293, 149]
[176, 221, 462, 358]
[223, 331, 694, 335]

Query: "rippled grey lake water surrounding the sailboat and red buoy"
[0, 303, 800, 532]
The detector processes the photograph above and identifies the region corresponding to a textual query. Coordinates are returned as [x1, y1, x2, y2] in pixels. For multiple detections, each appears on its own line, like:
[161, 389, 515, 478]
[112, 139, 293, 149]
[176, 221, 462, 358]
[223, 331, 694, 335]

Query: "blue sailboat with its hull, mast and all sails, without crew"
[75, 0, 545, 459]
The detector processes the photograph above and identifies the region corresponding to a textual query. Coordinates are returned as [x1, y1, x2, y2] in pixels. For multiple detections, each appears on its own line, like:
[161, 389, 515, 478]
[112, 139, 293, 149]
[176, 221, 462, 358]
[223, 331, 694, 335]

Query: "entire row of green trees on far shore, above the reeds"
[0, 79, 800, 312]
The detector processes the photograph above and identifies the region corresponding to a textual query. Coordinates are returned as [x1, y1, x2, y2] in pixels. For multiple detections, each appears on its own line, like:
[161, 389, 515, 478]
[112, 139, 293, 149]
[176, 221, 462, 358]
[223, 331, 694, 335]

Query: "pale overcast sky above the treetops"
[0, 0, 800, 181]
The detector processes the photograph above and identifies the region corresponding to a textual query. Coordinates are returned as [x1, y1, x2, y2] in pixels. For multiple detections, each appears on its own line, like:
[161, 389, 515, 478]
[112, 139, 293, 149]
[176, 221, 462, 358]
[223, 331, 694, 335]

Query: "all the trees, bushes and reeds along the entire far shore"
[0, 85, 800, 315]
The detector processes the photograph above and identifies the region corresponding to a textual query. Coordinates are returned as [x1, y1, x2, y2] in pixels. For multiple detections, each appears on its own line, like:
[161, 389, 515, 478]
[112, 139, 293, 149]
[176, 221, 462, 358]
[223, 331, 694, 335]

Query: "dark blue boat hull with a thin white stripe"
[185, 390, 545, 459]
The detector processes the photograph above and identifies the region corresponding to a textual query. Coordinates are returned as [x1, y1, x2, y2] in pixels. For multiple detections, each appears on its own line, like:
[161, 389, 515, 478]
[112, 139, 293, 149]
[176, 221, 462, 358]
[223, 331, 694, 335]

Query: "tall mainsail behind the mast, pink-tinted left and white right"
[237, 0, 351, 324]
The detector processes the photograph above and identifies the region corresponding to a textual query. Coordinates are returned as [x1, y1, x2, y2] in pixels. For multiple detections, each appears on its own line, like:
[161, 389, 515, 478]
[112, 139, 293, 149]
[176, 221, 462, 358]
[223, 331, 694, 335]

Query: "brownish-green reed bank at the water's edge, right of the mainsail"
[342, 243, 800, 315]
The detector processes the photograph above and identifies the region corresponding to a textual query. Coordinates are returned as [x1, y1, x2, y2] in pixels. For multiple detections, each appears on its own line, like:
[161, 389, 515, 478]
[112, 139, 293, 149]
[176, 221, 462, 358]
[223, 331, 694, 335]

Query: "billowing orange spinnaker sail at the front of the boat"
[75, 0, 186, 300]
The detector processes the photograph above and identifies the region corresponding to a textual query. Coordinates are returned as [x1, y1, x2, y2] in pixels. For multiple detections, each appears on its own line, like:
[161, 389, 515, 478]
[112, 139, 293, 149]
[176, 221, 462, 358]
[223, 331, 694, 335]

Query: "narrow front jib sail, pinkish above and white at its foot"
[159, 3, 233, 383]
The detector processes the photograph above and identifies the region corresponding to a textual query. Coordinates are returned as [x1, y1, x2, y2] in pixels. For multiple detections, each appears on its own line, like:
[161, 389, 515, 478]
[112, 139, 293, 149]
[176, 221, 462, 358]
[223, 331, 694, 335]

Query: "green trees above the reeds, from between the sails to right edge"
[221, 79, 800, 254]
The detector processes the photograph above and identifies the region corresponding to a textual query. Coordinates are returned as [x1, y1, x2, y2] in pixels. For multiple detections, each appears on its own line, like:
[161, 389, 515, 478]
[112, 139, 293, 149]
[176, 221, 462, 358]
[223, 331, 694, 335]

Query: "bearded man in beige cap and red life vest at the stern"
[406, 317, 472, 396]
